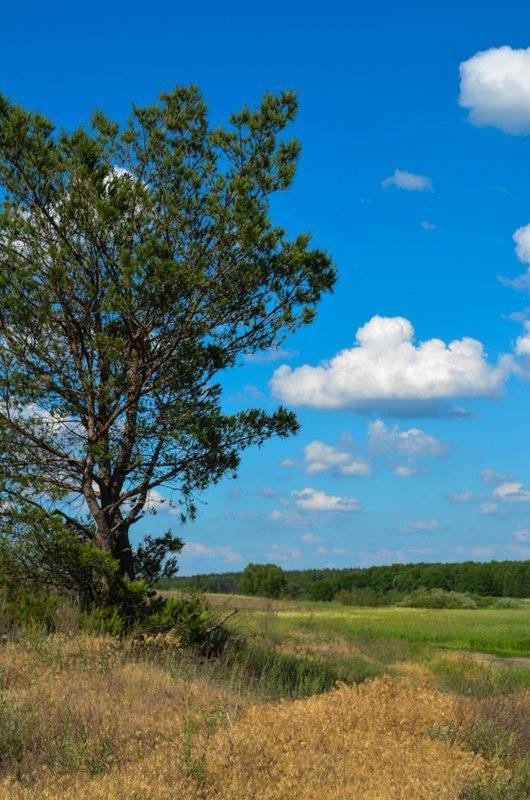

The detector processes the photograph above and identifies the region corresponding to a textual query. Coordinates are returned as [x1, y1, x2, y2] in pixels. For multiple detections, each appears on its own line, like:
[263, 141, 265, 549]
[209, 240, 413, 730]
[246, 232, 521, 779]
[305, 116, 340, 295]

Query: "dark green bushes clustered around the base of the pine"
[0, 511, 231, 654]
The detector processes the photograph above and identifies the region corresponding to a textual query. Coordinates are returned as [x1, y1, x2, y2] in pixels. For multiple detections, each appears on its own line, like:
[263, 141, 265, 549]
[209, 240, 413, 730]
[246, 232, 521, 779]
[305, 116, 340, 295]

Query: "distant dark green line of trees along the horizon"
[160, 561, 530, 600]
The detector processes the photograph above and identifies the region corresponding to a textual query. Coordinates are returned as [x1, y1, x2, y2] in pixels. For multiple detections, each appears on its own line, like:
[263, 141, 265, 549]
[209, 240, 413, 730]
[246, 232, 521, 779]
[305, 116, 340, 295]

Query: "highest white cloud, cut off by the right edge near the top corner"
[459, 45, 530, 134]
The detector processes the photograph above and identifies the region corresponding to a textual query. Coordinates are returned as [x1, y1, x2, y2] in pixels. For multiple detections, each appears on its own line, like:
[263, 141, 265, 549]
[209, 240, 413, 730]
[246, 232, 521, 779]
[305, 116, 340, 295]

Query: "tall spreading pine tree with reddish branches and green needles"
[0, 87, 335, 578]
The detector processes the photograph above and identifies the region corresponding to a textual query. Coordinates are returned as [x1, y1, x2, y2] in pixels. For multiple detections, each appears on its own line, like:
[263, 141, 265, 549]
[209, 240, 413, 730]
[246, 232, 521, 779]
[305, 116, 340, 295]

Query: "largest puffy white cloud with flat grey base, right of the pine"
[271, 316, 514, 416]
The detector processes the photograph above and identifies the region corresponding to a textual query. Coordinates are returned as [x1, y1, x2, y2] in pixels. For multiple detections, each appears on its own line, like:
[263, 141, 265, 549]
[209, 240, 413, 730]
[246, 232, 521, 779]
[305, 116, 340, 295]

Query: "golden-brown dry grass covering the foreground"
[0, 635, 527, 800]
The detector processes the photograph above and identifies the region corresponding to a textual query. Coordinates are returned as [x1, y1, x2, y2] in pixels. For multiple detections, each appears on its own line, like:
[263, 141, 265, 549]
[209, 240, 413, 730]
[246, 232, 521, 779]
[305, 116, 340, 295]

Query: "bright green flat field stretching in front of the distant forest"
[201, 595, 530, 657]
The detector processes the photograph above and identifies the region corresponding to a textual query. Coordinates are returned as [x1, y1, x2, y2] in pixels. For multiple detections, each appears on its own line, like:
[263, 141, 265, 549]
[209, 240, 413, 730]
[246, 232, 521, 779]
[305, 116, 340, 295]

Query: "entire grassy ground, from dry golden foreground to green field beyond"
[0, 596, 530, 800]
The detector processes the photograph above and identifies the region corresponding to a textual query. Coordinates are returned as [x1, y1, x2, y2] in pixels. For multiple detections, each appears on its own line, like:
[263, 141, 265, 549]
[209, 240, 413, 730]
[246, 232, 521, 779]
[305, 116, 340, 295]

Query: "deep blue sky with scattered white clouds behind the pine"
[4, 0, 530, 574]
